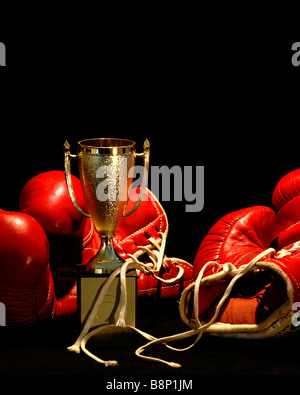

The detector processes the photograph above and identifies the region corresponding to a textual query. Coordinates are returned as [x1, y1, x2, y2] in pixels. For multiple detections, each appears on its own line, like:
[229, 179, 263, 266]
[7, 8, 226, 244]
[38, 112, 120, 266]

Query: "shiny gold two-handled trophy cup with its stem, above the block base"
[64, 138, 150, 274]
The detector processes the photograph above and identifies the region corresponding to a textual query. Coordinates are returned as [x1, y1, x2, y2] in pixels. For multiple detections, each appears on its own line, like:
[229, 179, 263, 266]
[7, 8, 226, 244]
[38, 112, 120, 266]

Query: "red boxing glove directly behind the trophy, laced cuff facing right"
[20, 171, 192, 317]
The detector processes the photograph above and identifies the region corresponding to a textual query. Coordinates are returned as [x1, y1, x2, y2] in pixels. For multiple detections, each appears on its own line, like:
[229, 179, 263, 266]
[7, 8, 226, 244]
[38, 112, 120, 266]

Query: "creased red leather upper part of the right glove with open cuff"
[193, 206, 276, 314]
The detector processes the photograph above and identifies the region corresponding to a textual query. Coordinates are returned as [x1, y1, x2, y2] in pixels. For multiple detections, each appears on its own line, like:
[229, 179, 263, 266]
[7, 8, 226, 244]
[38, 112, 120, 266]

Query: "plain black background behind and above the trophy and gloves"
[0, 4, 300, 386]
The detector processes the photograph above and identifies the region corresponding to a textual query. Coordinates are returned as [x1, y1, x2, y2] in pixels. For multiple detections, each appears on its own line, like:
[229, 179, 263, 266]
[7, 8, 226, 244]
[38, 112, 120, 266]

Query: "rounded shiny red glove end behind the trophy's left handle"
[19, 170, 86, 235]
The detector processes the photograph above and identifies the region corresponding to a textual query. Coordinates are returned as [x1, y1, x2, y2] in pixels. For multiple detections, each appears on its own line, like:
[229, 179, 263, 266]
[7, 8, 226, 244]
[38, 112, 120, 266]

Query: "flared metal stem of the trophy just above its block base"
[86, 236, 124, 274]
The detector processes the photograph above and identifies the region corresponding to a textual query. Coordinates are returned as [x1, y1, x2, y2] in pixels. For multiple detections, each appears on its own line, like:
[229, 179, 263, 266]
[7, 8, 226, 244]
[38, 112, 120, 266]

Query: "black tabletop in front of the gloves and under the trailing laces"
[0, 299, 300, 380]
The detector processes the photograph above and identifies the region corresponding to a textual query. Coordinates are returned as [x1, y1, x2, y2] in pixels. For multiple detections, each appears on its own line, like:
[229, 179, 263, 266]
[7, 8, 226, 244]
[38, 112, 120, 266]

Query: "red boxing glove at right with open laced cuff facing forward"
[180, 206, 300, 338]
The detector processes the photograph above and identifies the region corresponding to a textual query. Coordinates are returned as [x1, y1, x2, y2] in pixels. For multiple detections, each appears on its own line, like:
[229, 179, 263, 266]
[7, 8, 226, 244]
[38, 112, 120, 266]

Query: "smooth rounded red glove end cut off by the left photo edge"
[0, 210, 54, 326]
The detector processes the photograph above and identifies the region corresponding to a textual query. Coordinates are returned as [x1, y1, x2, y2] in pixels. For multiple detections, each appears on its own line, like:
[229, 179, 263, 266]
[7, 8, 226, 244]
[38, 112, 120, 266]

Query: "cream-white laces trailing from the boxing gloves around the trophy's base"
[68, 241, 275, 368]
